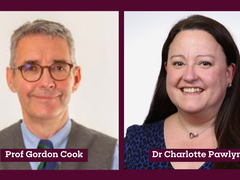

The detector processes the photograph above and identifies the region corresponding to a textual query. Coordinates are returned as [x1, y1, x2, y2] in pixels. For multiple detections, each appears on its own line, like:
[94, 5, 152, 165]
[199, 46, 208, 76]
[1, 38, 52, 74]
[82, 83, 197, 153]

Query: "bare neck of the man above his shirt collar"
[23, 112, 69, 139]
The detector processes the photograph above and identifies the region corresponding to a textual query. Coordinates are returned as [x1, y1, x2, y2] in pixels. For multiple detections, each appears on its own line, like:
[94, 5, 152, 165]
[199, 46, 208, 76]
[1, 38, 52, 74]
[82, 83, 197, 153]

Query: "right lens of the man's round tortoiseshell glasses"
[50, 63, 71, 80]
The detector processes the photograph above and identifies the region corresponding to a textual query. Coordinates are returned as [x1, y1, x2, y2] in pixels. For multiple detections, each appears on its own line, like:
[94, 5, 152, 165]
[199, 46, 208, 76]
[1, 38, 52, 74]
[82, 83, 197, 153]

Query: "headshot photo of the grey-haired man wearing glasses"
[0, 11, 119, 170]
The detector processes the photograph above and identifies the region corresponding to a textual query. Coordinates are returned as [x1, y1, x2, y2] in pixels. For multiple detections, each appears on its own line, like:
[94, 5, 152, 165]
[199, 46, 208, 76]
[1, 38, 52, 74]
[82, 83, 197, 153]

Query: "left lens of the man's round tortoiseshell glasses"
[22, 64, 41, 81]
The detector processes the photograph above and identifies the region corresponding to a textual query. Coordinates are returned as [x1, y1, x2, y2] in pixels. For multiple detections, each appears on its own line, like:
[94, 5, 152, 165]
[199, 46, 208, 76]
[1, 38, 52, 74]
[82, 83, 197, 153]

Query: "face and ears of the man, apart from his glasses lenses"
[7, 35, 80, 120]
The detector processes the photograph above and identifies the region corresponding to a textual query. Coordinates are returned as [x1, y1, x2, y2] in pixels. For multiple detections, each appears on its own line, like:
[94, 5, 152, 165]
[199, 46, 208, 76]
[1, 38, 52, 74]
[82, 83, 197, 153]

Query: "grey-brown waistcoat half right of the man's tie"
[63, 121, 117, 170]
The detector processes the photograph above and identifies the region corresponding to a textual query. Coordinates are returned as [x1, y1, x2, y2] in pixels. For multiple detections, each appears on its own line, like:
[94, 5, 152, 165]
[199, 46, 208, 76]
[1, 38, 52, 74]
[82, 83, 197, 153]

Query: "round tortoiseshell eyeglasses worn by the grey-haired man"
[12, 62, 73, 82]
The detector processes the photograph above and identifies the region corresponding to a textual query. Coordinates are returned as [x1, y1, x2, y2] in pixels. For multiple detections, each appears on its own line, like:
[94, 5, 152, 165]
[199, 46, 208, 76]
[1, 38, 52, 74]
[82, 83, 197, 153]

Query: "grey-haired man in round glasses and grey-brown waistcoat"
[0, 20, 118, 170]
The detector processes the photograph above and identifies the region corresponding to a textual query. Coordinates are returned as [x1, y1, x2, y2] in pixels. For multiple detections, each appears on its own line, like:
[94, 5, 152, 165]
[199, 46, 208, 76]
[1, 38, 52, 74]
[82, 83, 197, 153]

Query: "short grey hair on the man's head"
[9, 19, 76, 67]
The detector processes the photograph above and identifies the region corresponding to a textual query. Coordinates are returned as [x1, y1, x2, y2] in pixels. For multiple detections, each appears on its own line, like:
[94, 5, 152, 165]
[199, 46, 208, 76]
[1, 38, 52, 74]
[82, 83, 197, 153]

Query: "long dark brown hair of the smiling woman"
[144, 15, 240, 169]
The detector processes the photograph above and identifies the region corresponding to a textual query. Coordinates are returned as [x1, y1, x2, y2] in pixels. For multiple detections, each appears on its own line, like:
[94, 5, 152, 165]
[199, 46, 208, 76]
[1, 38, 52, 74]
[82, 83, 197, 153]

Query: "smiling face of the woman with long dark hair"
[165, 30, 235, 118]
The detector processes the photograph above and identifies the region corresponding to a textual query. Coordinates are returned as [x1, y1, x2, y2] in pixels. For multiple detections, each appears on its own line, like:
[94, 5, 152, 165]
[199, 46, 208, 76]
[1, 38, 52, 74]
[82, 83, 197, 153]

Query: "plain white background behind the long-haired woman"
[124, 11, 240, 134]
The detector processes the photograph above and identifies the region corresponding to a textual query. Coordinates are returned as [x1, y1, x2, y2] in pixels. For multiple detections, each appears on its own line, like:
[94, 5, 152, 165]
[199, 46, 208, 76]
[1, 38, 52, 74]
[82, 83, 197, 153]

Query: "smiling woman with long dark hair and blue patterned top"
[124, 15, 240, 169]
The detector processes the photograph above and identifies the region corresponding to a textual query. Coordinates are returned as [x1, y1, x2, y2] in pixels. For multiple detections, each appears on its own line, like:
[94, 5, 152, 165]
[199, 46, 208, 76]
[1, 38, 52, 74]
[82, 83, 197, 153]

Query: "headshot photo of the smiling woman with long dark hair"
[124, 11, 240, 169]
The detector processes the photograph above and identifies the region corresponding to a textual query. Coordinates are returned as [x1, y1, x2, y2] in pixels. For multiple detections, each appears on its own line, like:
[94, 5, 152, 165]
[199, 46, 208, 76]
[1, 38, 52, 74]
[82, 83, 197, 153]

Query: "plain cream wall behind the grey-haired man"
[0, 11, 119, 138]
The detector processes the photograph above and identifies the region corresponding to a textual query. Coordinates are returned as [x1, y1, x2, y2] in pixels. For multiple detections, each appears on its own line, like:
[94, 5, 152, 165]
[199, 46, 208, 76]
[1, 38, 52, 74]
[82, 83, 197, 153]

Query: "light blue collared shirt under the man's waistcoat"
[21, 119, 119, 170]
